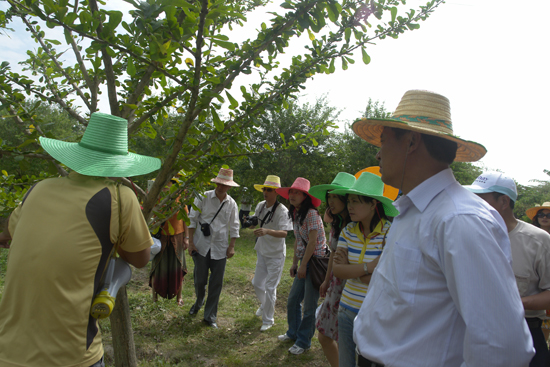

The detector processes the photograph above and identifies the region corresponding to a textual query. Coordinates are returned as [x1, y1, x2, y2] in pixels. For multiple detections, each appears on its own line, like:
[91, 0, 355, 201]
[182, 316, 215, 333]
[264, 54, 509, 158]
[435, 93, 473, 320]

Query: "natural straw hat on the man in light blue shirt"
[352, 90, 487, 162]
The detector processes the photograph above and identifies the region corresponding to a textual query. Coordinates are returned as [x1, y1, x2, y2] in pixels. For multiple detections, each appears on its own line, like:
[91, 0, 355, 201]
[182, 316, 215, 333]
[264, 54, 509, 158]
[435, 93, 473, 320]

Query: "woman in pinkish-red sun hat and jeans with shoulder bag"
[277, 177, 327, 354]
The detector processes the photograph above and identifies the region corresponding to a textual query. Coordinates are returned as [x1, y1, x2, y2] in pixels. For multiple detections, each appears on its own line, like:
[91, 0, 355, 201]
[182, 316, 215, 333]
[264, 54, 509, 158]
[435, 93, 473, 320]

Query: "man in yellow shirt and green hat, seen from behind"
[0, 112, 160, 367]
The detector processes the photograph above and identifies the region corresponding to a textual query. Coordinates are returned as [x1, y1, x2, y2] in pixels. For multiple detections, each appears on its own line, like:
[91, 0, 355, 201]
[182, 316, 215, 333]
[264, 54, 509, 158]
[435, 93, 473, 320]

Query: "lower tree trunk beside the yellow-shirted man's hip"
[110, 286, 137, 367]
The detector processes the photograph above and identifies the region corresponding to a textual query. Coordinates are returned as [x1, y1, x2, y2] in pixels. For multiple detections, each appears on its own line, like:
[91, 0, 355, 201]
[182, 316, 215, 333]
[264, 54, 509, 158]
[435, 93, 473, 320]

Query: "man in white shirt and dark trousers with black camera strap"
[188, 168, 239, 329]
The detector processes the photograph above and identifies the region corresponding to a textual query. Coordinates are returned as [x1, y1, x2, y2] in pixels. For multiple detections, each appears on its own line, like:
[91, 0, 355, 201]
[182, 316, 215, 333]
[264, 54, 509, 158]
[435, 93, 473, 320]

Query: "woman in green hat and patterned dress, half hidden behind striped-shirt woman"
[309, 172, 355, 367]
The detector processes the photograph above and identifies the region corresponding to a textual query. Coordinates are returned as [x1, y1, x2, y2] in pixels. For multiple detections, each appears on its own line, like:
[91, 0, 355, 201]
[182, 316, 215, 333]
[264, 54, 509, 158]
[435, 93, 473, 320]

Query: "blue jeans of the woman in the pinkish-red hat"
[286, 269, 319, 349]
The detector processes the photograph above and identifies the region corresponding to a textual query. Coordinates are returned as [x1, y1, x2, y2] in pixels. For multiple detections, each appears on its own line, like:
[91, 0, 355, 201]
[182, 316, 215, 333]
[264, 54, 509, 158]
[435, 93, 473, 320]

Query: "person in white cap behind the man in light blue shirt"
[466, 172, 550, 367]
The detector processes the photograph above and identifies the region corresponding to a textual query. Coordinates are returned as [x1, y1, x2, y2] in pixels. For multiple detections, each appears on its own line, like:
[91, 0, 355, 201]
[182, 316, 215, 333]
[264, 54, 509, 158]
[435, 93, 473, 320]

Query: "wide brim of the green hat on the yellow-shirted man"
[40, 137, 161, 177]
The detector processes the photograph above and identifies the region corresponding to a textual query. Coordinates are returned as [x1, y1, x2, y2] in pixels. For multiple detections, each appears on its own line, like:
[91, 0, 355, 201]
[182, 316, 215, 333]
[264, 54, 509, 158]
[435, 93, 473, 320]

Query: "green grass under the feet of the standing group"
[0, 229, 328, 367]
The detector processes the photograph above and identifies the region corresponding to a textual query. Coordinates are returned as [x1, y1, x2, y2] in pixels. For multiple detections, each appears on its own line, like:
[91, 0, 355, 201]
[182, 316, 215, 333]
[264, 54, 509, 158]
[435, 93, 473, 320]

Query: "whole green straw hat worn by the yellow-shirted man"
[40, 112, 161, 177]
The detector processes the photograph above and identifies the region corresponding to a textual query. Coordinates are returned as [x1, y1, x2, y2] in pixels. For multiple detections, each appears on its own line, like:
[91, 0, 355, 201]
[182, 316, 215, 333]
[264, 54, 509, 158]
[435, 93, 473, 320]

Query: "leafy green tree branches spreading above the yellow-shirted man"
[0, 0, 442, 218]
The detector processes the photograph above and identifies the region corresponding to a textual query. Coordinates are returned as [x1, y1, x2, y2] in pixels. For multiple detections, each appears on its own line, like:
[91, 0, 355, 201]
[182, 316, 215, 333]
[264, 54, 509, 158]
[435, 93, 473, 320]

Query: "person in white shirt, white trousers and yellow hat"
[252, 175, 293, 331]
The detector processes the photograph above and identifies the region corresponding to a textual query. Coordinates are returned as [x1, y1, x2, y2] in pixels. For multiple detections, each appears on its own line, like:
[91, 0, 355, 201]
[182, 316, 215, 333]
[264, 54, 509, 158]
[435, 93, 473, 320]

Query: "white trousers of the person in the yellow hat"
[252, 253, 285, 324]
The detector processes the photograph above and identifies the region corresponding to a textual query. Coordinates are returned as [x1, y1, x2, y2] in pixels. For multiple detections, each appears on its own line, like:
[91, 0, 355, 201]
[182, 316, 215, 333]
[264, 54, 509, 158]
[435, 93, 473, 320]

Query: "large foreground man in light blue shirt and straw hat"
[352, 90, 534, 367]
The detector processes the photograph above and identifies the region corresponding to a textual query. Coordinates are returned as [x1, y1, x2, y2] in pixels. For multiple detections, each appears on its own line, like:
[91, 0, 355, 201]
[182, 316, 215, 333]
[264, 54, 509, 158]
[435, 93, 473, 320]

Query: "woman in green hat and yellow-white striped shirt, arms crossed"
[330, 172, 399, 366]
